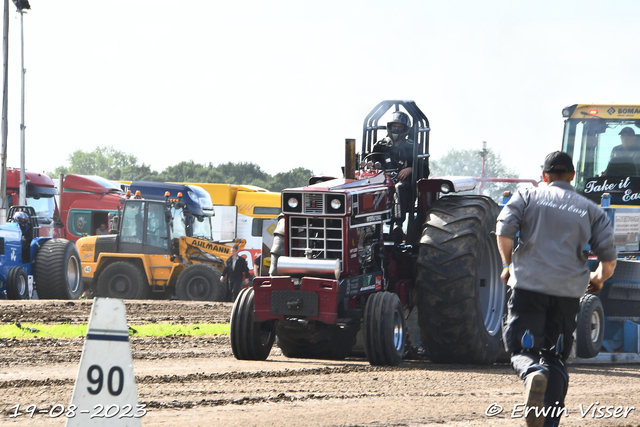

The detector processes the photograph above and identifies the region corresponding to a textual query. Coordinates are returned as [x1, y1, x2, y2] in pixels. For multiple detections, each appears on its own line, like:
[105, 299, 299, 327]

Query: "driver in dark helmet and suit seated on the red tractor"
[373, 111, 413, 229]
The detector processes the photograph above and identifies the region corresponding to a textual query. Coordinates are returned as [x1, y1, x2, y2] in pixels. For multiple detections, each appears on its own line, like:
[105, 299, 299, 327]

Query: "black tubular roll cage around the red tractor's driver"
[362, 100, 431, 231]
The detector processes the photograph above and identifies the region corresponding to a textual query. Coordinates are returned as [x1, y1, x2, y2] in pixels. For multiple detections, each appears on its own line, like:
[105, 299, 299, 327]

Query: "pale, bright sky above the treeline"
[2, 0, 640, 178]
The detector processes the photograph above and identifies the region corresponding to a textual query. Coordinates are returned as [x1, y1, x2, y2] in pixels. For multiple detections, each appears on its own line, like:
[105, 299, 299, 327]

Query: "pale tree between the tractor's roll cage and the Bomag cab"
[429, 149, 518, 201]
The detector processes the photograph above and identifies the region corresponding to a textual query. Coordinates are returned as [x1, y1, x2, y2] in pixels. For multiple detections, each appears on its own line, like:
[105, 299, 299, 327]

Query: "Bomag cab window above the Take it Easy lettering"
[562, 118, 640, 190]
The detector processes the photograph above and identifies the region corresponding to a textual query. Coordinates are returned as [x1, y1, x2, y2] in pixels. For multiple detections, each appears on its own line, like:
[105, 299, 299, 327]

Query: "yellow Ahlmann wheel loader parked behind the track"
[76, 192, 245, 301]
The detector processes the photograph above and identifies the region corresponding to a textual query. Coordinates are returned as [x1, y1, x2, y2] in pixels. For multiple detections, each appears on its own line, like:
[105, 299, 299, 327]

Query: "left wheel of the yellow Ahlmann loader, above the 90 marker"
[98, 261, 149, 299]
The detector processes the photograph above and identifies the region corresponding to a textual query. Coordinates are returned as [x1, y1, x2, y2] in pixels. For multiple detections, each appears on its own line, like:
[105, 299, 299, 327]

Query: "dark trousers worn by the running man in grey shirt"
[503, 289, 580, 426]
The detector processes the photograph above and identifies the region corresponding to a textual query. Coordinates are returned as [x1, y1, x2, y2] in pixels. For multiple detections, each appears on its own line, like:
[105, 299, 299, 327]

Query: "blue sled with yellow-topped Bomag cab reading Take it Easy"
[562, 104, 640, 363]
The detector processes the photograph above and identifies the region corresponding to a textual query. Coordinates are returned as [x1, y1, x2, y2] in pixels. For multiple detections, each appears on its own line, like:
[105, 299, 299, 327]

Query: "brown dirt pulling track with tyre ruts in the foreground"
[0, 301, 640, 427]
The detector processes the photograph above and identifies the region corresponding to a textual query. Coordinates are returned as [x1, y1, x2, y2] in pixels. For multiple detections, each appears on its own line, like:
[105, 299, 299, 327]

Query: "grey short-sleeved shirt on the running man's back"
[496, 181, 617, 298]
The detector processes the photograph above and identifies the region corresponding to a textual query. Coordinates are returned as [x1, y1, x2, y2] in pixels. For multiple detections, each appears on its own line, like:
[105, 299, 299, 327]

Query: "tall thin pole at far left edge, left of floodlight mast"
[0, 0, 9, 225]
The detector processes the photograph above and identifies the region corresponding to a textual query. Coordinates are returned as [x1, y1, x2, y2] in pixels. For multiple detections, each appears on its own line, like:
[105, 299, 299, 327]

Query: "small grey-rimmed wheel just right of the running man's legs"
[576, 294, 604, 359]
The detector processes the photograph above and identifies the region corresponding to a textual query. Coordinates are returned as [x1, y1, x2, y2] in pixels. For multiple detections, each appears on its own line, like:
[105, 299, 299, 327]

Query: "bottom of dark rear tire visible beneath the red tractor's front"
[276, 320, 360, 360]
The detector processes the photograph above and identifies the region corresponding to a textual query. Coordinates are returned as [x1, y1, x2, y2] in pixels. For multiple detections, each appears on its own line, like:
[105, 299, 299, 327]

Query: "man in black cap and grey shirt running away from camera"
[496, 151, 617, 427]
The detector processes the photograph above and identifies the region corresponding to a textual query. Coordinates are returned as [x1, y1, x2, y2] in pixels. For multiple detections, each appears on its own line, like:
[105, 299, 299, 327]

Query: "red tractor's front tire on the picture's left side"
[229, 288, 276, 360]
